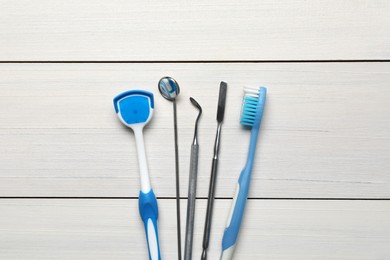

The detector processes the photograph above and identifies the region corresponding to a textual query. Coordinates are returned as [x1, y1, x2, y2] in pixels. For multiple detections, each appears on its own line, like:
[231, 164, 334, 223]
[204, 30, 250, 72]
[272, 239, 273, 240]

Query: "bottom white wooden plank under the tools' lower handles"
[0, 199, 390, 260]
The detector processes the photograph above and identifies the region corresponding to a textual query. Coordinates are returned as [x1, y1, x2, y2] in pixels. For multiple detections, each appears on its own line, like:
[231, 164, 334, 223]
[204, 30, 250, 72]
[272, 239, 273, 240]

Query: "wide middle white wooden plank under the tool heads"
[0, 63, 390, 198]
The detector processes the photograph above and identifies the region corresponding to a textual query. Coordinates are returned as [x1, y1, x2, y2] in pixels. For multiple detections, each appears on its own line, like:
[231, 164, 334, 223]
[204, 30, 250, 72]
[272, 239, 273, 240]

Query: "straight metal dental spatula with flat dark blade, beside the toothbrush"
[201, 81, 227, 260]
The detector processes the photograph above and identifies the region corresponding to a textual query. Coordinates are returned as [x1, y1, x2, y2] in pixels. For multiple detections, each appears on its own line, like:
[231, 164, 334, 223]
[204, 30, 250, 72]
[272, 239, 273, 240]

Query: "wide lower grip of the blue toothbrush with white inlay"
[220, 167, 251, 260]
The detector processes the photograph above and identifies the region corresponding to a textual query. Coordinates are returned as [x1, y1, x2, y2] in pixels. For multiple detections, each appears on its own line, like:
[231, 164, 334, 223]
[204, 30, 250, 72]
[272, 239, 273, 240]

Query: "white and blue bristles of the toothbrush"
[240, 87, 260, 127]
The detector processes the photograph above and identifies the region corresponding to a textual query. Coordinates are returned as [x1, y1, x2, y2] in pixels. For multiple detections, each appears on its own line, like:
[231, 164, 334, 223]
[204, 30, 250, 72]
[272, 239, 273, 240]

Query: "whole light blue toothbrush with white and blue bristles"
[220, 87, 267, 260]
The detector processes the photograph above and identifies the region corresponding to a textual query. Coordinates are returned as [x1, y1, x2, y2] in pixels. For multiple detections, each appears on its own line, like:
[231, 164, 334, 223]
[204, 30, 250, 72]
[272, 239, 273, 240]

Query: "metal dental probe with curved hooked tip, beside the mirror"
[184, 97, 202, 260]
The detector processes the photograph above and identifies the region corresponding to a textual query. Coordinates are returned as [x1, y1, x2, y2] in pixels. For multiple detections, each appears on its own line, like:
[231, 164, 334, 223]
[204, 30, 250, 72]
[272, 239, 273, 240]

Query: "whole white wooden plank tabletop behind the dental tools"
[0, 0, 390, 260]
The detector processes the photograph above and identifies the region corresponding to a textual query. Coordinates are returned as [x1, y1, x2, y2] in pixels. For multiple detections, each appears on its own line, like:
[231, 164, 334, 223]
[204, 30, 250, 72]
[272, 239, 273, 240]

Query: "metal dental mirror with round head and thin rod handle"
[158, 77, 181, 260]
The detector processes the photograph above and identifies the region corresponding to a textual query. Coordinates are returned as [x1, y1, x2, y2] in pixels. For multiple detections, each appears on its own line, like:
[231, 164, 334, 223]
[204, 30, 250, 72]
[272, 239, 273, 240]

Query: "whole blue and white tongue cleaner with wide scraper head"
[114, 90, 161, 260]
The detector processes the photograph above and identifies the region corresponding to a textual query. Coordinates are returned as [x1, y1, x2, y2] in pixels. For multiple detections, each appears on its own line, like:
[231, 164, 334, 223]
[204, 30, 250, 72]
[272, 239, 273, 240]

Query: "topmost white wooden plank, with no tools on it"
[0, 0, 390, 61]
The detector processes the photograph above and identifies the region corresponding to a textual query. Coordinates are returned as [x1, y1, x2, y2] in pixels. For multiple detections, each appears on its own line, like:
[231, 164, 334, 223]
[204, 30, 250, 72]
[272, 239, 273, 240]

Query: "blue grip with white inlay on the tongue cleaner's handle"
[138, 189, 161, 260]
